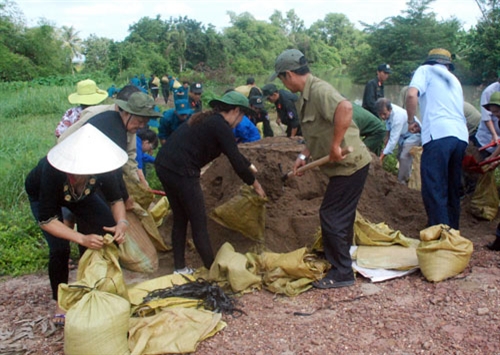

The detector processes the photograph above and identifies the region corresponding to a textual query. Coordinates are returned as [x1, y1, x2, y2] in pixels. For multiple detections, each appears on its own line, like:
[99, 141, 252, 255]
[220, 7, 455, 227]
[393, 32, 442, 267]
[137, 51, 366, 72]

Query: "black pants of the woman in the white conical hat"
[29, 193, 116, 300]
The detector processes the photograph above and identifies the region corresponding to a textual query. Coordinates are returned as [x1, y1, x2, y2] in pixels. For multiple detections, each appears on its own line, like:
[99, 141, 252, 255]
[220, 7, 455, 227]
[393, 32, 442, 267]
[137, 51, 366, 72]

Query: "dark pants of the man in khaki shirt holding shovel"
[319, 164, 370, 281]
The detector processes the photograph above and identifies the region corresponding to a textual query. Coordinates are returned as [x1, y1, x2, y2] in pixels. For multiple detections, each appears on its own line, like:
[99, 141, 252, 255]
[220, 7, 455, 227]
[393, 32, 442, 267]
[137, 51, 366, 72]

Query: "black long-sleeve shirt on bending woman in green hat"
[155, 114, 255, 185]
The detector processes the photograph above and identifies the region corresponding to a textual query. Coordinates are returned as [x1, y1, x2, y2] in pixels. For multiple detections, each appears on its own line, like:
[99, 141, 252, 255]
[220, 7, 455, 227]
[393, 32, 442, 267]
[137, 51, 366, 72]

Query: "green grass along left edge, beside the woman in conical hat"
[0, 87, 64, 276]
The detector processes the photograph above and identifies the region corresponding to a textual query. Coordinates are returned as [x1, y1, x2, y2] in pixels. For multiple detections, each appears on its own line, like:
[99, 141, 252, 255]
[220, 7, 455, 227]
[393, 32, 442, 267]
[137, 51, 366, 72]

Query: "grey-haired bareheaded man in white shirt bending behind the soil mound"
[375, 97, 422, 184]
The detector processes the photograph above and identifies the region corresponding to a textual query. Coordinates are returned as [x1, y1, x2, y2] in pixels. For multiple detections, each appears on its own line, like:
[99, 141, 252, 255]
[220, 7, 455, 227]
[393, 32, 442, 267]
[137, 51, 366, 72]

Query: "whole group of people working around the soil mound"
[26, 48, 500, 330]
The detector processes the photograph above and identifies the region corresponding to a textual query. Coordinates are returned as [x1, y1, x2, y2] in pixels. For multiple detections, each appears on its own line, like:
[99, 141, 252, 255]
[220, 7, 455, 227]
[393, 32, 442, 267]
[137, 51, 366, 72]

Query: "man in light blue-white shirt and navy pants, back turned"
[406, 48, 469, 230]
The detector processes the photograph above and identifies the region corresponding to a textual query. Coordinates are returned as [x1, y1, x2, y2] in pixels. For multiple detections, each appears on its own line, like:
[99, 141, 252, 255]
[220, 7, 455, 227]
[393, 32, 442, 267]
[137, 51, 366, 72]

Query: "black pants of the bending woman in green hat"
[156, 165, 214, 269]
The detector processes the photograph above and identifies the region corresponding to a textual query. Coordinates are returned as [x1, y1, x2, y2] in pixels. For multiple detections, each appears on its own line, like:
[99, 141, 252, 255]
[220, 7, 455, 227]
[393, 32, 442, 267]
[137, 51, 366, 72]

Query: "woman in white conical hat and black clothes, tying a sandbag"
[25, 125, 128, 324]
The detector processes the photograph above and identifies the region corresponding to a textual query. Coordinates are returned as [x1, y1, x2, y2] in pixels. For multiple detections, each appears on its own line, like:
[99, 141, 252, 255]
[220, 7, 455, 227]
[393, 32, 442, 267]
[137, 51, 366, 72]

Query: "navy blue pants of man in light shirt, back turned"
[420, 137, 467, 230]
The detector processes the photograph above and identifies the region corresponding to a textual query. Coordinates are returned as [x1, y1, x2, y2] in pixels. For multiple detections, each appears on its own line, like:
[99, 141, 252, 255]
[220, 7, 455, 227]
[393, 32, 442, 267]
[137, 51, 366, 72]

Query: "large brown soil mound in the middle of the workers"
[197, 137, 426, 253]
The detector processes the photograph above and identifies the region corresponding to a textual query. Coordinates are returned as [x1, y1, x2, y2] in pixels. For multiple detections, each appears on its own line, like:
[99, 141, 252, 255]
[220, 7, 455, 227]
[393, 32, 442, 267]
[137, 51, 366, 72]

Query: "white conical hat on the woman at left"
[47, 124, 128, 175]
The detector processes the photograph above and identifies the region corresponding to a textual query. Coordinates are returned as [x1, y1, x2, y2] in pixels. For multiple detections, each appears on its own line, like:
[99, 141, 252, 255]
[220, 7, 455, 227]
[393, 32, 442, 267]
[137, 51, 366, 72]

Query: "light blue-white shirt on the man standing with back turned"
[410, 64, 469, 144]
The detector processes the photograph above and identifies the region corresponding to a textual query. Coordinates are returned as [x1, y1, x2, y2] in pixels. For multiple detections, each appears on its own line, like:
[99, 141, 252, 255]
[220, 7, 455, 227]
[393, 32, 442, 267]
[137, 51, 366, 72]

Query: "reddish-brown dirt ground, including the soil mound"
[0, 137, 500, 355]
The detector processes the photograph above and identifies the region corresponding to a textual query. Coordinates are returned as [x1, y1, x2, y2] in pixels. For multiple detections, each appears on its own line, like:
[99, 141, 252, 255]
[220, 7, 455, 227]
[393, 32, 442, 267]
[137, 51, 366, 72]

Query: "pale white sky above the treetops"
[14, 0, 481, 41]
